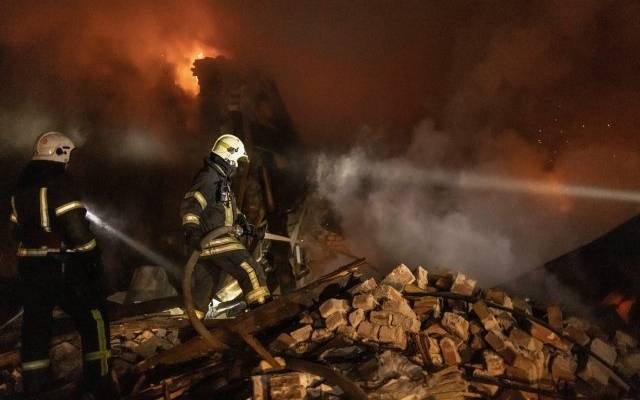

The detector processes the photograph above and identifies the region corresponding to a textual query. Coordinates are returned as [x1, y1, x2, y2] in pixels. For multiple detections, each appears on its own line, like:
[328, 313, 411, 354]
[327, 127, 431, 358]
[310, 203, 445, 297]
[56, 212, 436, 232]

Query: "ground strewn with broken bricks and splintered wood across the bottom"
[0, 265, 640, 400]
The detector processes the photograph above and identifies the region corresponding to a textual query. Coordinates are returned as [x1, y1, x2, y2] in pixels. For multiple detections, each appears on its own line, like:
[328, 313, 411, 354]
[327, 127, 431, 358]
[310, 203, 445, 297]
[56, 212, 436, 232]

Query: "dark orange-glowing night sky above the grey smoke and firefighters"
[0, 0, 640, 286]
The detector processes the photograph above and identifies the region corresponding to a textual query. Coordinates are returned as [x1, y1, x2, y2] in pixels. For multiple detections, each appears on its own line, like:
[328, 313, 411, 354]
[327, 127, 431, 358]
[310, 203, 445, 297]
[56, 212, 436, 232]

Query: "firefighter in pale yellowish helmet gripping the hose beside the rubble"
[180, 134, 270, 310]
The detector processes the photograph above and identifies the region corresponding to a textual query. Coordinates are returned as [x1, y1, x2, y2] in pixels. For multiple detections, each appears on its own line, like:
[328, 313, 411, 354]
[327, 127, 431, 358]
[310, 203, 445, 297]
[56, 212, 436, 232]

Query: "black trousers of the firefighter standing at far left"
[18, 257, 111, 394]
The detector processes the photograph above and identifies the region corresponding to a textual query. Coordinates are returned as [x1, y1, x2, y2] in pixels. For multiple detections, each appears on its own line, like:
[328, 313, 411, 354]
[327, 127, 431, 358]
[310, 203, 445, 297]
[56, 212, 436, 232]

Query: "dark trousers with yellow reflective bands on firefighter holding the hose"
[194, 250, 270, 310]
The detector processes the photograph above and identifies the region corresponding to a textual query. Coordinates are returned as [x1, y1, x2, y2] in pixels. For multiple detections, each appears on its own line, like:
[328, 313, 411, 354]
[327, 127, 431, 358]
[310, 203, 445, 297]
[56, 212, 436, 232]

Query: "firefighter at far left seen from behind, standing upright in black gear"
[10, 132, 110, 398]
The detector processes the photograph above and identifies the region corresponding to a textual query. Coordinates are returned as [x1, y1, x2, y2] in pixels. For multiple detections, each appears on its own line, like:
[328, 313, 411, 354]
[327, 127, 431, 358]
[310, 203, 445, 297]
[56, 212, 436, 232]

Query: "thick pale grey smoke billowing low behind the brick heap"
[315, 121, 638, 285]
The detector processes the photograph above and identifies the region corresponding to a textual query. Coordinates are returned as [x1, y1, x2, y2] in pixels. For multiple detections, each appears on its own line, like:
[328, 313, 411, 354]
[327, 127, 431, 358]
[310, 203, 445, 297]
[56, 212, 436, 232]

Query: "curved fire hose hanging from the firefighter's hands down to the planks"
[182, 226, 235, 350]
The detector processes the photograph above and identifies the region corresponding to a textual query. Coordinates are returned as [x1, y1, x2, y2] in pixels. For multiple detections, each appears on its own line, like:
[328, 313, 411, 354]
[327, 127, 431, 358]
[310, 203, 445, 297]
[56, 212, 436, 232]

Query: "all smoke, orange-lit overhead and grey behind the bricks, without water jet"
[0, 0, 640, 290]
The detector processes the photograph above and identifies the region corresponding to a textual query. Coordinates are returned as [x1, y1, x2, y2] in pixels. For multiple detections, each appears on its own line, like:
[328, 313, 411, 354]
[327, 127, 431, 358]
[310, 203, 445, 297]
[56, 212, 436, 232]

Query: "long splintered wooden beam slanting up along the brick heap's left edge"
[135, 259, 365, 374]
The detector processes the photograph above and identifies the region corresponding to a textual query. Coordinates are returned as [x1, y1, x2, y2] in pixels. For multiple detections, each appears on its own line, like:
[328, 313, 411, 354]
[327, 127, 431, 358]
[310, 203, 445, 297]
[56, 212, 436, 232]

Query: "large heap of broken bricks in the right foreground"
[251, 265, 640, 400]
